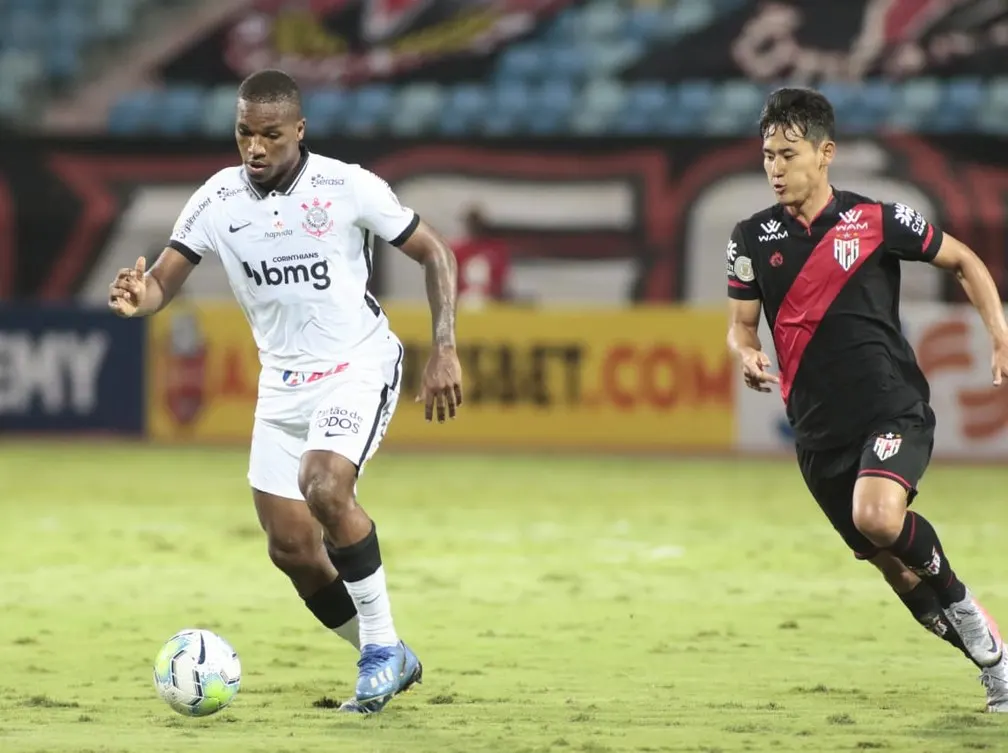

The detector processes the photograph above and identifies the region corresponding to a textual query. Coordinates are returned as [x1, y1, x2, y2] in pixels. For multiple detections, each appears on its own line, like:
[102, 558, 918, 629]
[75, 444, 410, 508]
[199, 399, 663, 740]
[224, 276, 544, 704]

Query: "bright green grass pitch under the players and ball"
[0, 443, 1008, 753]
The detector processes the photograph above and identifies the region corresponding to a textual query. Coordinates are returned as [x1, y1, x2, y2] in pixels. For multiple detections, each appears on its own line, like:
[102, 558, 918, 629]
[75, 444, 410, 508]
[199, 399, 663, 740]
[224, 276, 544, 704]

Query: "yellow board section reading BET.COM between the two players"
[386, 306, 735, 451]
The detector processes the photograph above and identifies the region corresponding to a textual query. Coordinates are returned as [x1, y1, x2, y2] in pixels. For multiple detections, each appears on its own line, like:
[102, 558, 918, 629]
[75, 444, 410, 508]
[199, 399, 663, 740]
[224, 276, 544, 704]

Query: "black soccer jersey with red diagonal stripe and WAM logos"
[728, 191, 942, 450]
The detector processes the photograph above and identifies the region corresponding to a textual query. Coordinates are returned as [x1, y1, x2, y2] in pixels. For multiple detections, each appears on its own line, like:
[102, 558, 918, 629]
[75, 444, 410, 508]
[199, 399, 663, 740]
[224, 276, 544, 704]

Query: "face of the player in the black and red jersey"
[763, 126, 834, 207]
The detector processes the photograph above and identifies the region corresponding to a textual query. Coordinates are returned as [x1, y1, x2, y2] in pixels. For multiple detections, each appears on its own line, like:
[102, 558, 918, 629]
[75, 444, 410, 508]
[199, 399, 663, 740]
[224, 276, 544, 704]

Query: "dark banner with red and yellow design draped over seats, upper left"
[161, 0, 572, 88]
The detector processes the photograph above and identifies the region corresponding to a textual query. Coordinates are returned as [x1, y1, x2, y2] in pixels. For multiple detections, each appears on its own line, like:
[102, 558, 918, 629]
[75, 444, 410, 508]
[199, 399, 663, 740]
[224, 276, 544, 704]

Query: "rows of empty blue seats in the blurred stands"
[0, 0, 1008, 137]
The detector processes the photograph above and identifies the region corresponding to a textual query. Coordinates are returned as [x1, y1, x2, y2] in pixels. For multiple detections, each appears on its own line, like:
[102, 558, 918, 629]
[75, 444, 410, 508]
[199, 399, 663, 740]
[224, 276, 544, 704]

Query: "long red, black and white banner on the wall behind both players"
[0, 136, 1008, 301]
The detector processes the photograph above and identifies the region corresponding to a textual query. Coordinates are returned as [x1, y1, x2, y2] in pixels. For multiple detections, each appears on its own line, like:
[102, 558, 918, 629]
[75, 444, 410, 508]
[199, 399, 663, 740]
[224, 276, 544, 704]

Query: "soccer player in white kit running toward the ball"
[109, 71, 462, 713]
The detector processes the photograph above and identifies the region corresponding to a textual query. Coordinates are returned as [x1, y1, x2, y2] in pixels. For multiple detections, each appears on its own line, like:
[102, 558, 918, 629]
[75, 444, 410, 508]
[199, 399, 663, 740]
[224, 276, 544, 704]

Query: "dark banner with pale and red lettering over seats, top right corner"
[627, 0, 1008, 83]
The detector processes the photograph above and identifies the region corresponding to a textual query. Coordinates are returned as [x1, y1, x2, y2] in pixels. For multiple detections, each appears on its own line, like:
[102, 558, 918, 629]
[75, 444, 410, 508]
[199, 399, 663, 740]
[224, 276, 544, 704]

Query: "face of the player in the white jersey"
[235, 100, 304, 184]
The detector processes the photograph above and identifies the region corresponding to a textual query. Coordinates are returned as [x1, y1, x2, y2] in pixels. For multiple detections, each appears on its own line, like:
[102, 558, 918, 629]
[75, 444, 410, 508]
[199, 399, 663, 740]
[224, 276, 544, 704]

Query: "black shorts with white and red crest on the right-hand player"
[795, 403, 934, 559]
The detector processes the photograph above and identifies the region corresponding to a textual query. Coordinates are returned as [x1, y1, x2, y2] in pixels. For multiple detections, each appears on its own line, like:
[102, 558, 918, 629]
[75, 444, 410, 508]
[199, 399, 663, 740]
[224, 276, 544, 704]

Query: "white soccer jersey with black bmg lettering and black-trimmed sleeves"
[168, 147, 419, 371]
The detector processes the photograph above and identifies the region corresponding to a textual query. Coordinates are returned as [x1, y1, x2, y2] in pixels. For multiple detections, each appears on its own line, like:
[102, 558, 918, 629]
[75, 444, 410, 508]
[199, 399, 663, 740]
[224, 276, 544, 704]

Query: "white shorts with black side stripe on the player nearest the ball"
[248, 337, 402, 500]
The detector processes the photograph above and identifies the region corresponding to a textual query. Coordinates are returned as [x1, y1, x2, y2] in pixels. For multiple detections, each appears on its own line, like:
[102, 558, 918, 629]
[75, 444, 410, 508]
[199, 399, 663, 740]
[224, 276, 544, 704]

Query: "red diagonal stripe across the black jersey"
[773, 204, 883, 404]
